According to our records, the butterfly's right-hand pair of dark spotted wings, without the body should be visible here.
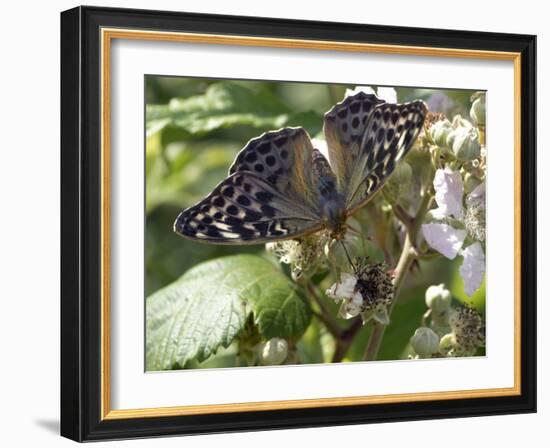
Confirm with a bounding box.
[325,92,427,215]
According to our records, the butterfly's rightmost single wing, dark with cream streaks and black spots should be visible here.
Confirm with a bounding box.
[346,101,428,215]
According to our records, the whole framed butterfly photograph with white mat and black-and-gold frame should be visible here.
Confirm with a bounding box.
[61,7,536,441]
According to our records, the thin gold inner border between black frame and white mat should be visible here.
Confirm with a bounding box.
[100,28,521,420]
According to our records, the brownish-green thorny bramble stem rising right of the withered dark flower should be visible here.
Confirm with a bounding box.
[364,191,433,361]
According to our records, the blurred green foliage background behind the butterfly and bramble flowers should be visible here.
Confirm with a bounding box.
[145,76,484,359]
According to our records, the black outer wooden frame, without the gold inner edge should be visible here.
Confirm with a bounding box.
[61,7,536,441]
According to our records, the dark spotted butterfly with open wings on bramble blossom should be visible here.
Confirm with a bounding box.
[174,92,427,244]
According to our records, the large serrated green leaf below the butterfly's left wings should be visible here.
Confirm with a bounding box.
[146,255,311,370]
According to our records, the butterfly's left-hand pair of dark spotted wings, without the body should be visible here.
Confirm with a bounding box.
[174,128,322,244]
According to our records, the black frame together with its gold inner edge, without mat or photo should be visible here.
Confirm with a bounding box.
[61,7,537,441]
